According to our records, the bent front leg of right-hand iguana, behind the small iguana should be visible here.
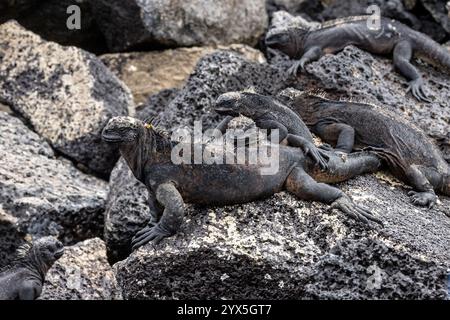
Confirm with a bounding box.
[314,122,355,153]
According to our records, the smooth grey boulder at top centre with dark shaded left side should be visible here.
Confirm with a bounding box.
[90,0,268,51]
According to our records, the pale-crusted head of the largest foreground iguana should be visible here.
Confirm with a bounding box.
[102,117,144,144]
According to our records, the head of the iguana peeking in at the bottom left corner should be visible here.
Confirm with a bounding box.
[17,237,64,270]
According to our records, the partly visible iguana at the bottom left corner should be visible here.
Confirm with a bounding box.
[0,237,64,300]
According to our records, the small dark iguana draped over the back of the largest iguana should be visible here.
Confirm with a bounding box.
[214,90,328,170]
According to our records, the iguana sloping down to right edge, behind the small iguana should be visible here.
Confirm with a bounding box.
[279,89,450,208]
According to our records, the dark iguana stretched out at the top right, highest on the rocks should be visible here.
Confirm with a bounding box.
[266,16,450,102]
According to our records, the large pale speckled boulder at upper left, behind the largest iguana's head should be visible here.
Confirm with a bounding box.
[0,22,134,176]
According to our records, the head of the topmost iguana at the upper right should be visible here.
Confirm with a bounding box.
[266,27,308,58]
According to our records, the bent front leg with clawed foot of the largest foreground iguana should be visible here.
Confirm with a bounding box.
[131,182,184,250]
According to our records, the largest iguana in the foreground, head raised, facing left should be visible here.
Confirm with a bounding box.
[102,117,380,249]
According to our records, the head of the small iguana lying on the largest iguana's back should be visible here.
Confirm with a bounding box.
[214,91,271,119]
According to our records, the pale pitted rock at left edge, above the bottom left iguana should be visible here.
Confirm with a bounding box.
[0,112,108,243]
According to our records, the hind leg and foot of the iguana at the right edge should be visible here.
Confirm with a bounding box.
[405,166,437,209]
